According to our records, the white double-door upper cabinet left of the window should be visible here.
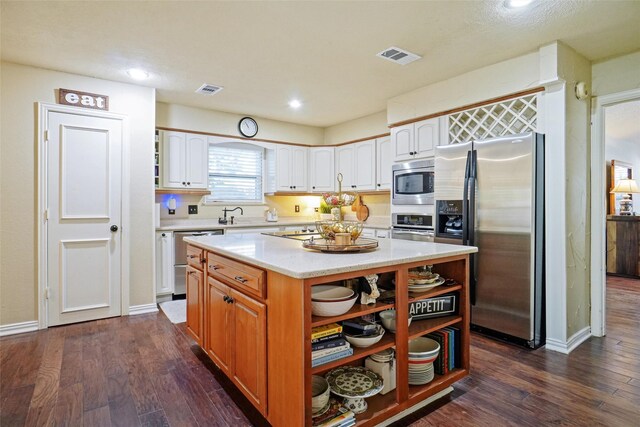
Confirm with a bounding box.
[162,131,208,189]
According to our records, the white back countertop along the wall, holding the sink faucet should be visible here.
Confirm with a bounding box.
[156,217,390,231]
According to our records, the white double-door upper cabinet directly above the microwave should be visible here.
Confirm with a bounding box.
[391,117,440,162]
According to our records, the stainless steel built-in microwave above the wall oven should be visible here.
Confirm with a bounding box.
[391,159,434,205]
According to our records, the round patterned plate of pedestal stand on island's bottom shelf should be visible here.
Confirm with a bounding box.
[325,366,383,397]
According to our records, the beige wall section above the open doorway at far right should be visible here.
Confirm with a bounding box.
[592,50,640,96]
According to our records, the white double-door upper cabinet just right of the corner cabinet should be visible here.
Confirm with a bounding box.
[335,139,376,191]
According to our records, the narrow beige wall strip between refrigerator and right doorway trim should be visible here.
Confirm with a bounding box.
[558,44,591,338]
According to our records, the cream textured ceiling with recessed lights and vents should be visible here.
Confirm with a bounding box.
[0,0,640,127]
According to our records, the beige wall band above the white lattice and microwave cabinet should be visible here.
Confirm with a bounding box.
[387,52,540,124]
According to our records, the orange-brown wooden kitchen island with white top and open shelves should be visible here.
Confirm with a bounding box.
[185,233,477,427]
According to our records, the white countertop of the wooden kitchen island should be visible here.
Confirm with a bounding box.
[184,233,478,279]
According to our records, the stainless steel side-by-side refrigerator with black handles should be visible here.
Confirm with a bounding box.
[434,133,545,348]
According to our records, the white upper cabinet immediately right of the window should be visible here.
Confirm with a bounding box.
[275,144,308,192]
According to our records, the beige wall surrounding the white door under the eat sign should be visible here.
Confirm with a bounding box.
[0,63,155,325]
